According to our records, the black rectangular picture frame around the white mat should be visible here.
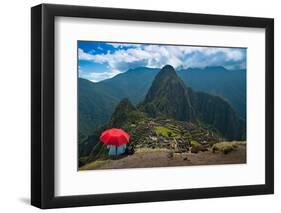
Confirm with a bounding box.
[31,4,274,209]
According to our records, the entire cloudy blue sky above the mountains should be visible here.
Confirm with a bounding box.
[78,41,247,82]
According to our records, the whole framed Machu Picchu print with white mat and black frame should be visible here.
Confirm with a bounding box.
[31,4,274,208]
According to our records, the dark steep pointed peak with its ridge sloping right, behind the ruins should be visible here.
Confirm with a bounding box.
[140,65,245,140]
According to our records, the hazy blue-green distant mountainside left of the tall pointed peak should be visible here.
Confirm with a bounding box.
[78,67,159,135]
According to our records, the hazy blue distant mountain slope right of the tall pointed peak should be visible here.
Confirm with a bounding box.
[177,67,246,119]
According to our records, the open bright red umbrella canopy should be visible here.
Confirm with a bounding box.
[100,128,130,146]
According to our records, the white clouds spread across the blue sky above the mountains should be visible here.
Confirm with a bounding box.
[78,43,246,79]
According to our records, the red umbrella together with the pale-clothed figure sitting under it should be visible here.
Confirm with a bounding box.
[100,128,130,157]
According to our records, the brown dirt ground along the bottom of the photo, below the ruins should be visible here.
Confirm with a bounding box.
[81,146,246,170]
